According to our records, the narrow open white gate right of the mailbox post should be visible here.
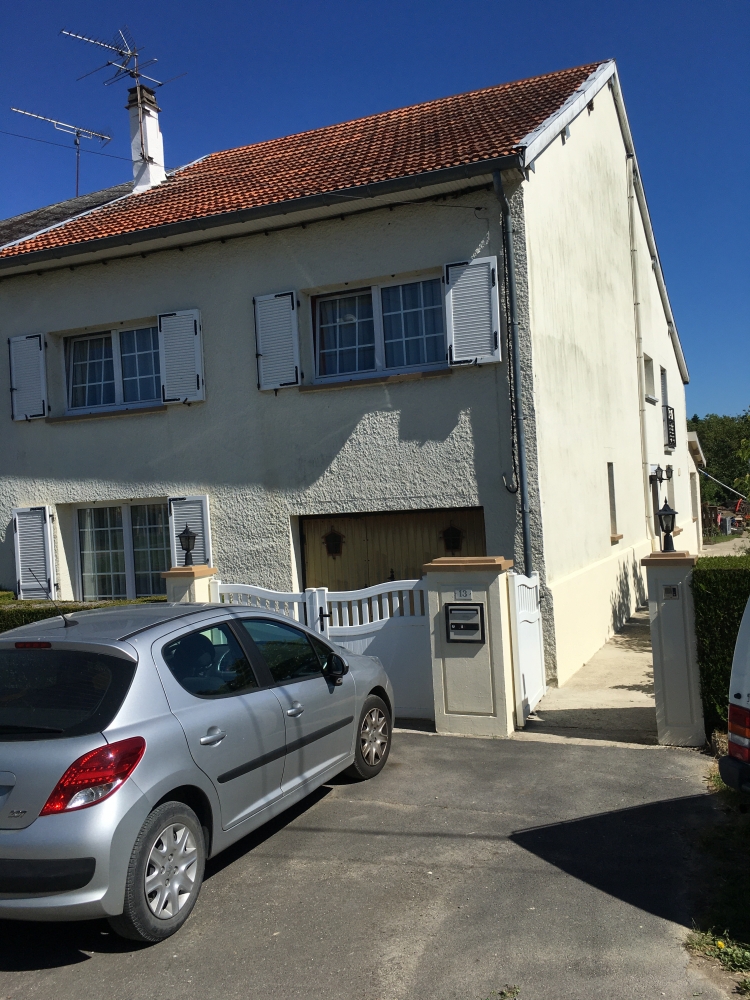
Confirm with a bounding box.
[508,571,546,726]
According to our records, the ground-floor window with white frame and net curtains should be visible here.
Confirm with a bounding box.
[78,502,171,601]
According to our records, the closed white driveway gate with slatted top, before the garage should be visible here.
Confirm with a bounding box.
[210,580,435,719]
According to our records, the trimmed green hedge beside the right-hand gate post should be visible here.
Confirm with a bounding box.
[693,556,750,736]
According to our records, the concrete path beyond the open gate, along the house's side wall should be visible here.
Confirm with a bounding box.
[518,611,657,744]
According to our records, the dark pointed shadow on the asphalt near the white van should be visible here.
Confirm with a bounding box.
[510,795,713,927]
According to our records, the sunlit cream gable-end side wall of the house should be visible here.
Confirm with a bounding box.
[524,90,695,683]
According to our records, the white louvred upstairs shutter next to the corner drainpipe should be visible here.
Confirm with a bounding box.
[445,257,501,365]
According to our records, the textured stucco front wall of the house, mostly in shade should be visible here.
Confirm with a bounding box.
[0,190,528,597]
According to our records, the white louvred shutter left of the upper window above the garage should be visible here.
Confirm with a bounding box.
[254,292,299,389]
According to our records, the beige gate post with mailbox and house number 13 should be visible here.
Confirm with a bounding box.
[424,556,515,736]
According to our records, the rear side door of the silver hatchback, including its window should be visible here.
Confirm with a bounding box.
[154,622,286,830]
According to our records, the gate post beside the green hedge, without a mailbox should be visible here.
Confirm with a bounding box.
[641,552,706,747]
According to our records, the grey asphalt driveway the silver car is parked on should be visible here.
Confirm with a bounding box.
[0,733,724,1000]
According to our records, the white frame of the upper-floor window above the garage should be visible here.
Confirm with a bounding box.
[310,267,450,385]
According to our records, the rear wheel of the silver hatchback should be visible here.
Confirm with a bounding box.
[109,802,206,943]
